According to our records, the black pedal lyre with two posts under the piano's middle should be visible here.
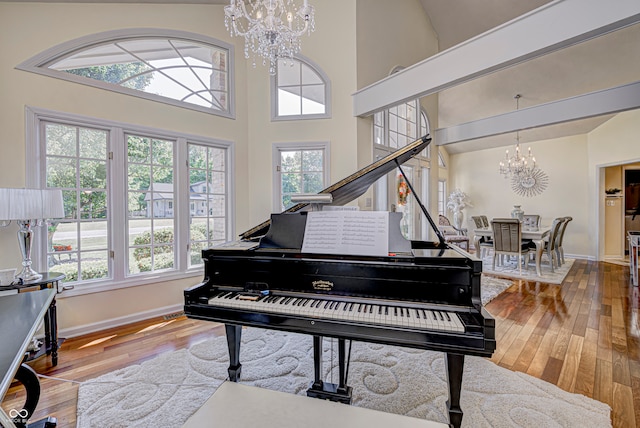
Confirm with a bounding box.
[307,336,352,404]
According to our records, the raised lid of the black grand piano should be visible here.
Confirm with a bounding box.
[240,135,431,239]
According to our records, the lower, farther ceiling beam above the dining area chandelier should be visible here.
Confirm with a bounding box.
[434,81,640,146]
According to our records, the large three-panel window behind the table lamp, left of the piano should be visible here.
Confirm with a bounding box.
[28,110,232,289]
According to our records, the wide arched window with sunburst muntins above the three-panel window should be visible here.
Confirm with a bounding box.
[16,29,234,117]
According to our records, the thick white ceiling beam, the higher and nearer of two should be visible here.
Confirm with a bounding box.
[353,0,640,116]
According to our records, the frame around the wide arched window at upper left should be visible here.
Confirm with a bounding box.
[15,28,236,119]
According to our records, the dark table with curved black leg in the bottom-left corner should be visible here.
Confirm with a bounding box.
[0,287,56,428]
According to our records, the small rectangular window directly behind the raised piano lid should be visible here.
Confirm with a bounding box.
[274,143,329,211]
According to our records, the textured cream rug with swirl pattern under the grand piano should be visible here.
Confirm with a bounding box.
[78,328,611,428]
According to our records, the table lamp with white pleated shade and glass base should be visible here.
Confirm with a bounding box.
[0,189,64,282]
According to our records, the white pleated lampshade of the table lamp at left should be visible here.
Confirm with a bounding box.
[0,189,64,220]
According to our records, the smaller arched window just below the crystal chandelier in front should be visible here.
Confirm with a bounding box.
[271,55,331,120]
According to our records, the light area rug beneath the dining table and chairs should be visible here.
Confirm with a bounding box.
[482,251,575,284]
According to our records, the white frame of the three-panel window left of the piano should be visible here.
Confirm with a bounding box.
[25,106,235,296]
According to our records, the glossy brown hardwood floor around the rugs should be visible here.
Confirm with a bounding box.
[2,260,640,428]
